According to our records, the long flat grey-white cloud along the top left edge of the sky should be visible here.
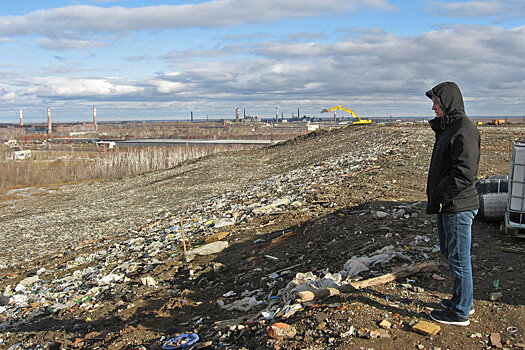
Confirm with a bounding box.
[0,0,395,38]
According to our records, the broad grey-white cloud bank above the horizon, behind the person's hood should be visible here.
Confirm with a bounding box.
[0,26,525,116]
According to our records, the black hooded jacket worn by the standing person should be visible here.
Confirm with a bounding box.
[426,82,480,214]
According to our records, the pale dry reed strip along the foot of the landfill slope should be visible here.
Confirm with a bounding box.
[0,145,250,190]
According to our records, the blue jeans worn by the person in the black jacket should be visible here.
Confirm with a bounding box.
[436,210,478,319]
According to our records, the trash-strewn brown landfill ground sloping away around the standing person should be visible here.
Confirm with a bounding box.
[0,125,525,350]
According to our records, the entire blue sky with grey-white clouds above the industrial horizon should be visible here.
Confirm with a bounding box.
[0,0,525,122]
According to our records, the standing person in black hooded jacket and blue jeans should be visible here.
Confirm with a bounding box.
[426,82,480,326]
